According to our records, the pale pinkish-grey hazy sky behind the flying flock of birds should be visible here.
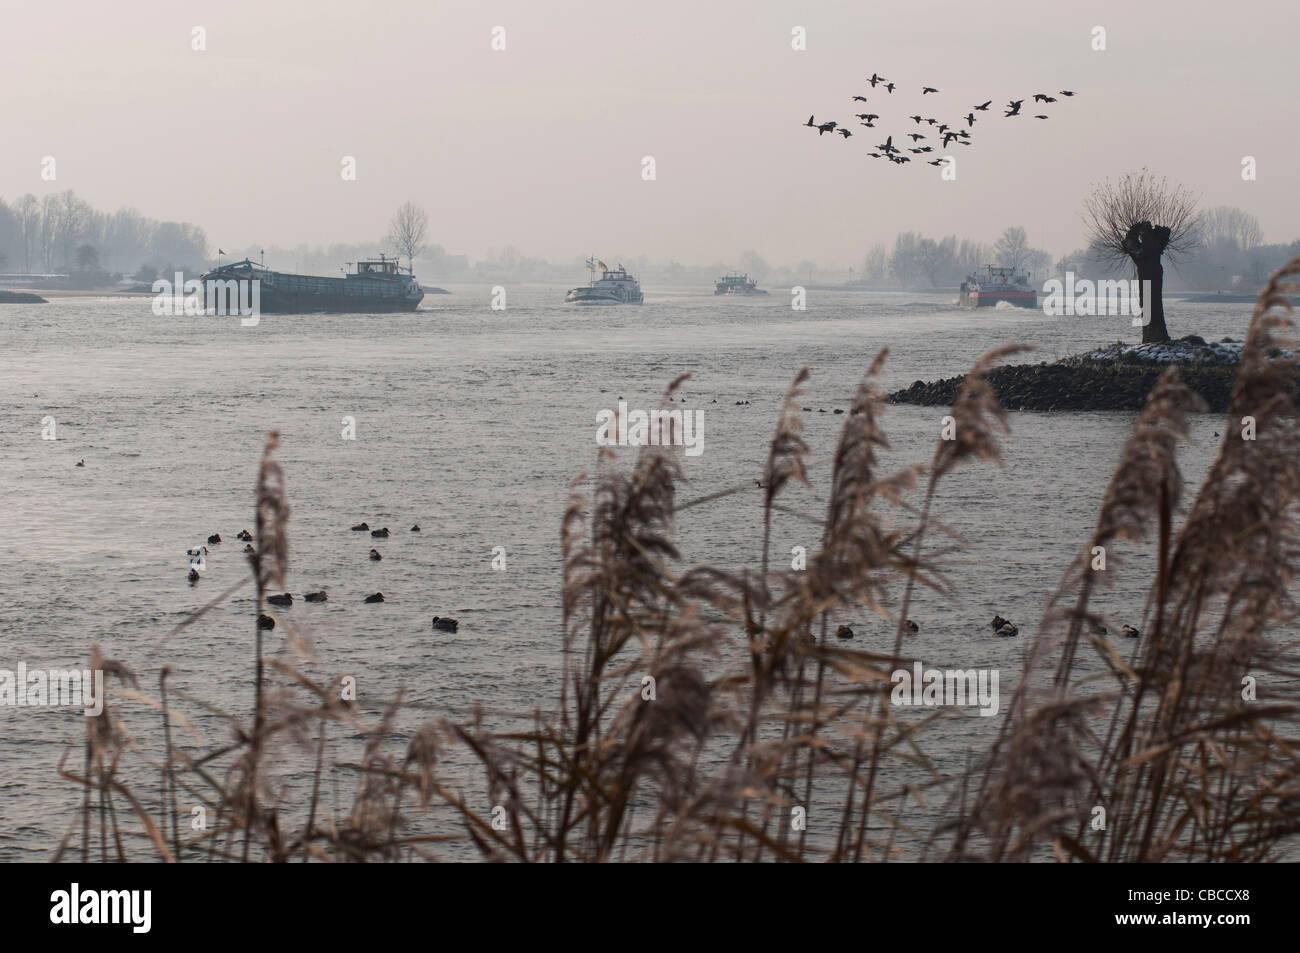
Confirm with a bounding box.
[0,0,1300,267]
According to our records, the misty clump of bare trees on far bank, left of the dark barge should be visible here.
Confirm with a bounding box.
[0,190,208,285]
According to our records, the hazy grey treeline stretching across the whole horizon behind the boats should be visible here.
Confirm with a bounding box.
[0,190,1300,291]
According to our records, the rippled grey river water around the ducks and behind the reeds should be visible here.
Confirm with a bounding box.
[0,286,1251,859]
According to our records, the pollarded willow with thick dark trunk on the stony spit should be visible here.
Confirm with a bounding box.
[1083,169,1200,345]
